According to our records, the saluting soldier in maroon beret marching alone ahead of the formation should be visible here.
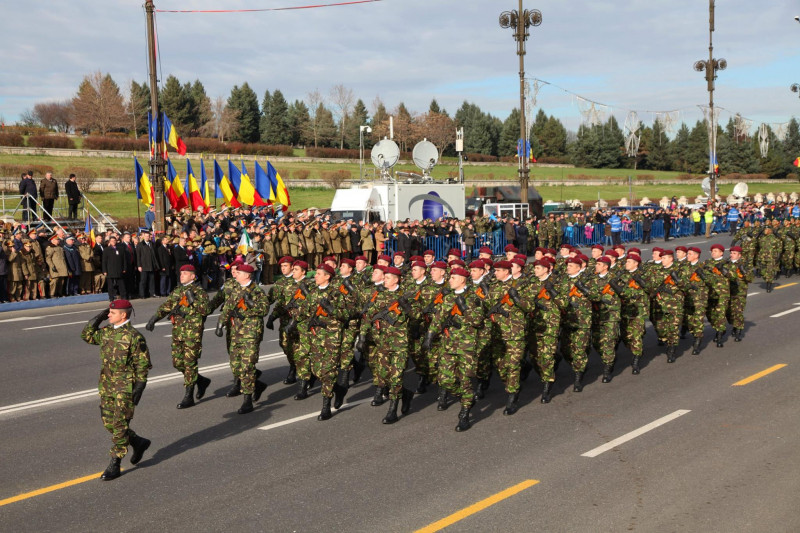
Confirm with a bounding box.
[81,300,152,481]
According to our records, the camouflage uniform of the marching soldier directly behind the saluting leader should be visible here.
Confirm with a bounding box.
[155,283,210,387]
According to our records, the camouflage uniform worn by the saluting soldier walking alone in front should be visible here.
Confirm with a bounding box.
[81,321,152,458]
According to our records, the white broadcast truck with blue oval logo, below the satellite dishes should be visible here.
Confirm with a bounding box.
[331,183,466,221]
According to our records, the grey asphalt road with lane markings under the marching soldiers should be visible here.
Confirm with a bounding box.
[0,236,800,532]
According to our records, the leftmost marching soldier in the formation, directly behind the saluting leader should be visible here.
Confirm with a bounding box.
[145,265,211,409]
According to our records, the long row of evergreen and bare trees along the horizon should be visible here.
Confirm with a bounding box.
[15,72,800,177]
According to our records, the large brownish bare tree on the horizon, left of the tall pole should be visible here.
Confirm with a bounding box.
[72,70,126,135]
